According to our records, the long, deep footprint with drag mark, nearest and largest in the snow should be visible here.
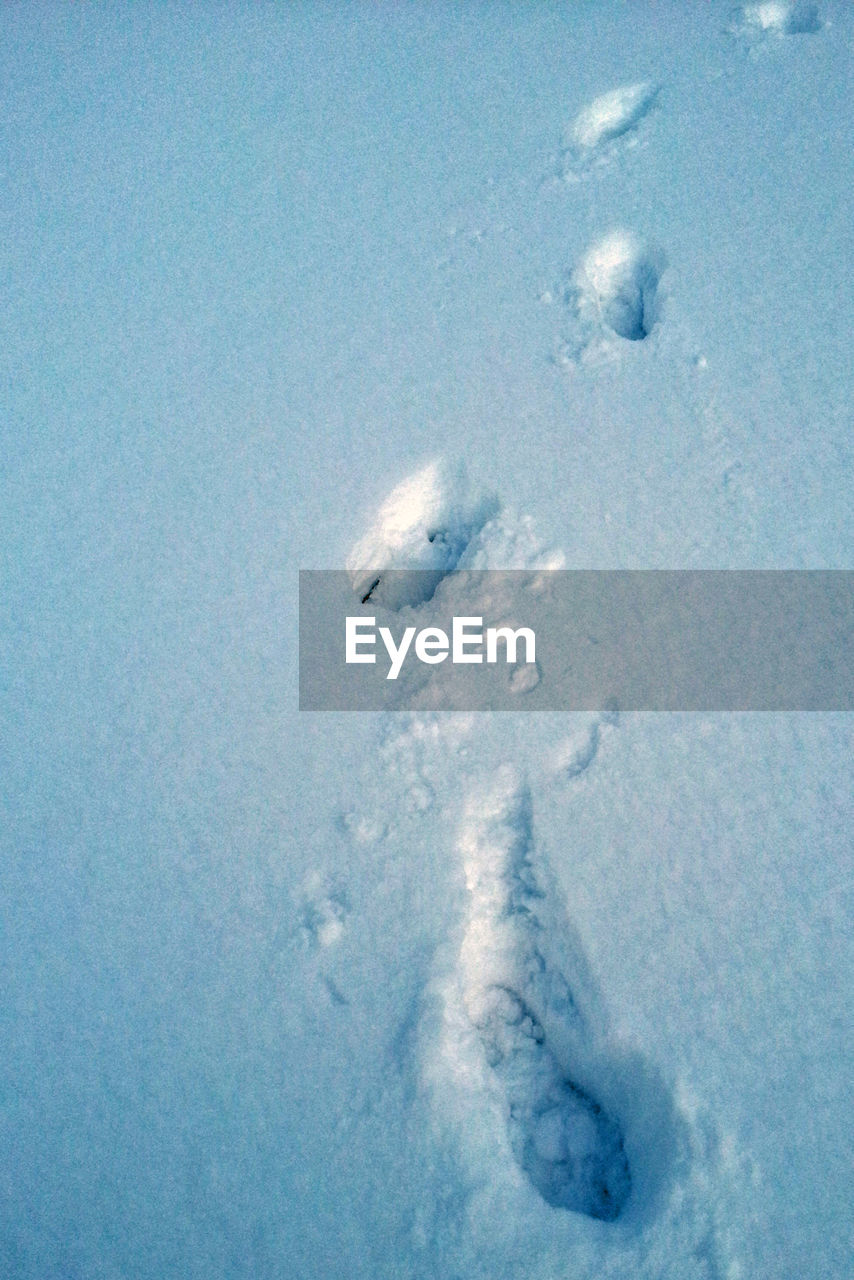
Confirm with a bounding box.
[460,772,631,1221]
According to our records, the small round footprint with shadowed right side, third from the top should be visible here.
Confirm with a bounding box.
[570,232,666,342]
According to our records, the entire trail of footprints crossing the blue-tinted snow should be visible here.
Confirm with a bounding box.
[332,0,822,1239]
